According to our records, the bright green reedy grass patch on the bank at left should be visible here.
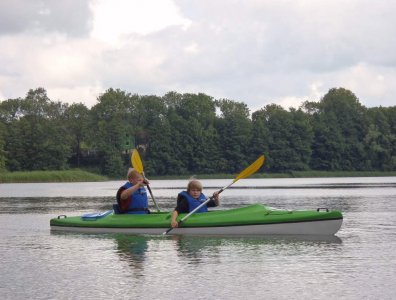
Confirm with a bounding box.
[0,169,108,183]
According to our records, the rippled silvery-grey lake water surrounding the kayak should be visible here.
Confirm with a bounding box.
[0,177,396,300]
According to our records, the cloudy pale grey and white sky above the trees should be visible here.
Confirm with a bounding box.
[0,0,396,111]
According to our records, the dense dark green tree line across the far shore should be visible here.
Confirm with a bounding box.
[0,88,396,177]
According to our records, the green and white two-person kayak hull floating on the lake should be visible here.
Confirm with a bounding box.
[50,204,343,235]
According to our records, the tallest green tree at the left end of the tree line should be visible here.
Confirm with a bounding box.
[6,88,70,171]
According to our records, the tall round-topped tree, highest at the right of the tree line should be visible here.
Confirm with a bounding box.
[311,88,367,170]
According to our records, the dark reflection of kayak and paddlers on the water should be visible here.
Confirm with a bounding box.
[51,231,342,277]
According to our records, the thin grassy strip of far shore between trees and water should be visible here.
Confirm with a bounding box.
[0,169,396,183]
